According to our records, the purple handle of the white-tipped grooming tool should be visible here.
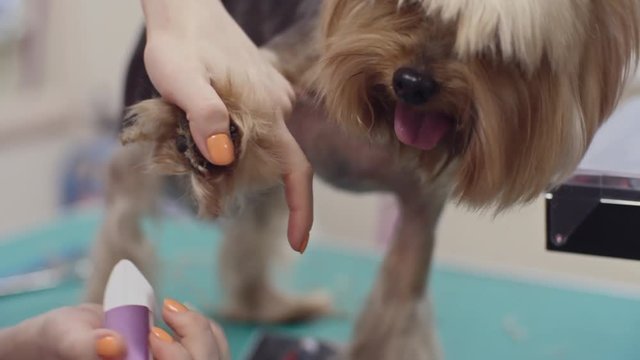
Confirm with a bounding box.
[105,305,151,360]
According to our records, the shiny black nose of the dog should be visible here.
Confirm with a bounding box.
[393,68,438,105]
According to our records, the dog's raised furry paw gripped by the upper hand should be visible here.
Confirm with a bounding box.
[121,82,282,217]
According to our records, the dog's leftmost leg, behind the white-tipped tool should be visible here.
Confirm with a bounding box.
[85,144,159,303]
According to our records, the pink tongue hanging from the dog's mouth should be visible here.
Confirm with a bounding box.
[394,102,451,150]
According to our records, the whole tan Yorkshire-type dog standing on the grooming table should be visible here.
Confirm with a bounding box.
[88,0,640,360]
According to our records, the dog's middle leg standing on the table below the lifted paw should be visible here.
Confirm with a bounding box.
[220,188,331,323]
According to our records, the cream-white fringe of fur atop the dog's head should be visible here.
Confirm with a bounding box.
[399,0,602,71]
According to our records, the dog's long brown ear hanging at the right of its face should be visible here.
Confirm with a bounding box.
[456,0,640,208]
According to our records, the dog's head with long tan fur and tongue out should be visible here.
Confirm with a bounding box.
[312,0,640,206]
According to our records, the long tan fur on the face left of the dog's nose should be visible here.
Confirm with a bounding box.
[307,0,423,138]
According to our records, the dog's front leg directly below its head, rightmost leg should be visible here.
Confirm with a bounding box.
[348,194,445,360]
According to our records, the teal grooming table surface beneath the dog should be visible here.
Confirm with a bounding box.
[0,212,640,360]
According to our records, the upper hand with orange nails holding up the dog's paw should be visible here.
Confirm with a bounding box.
[141,0,313,252]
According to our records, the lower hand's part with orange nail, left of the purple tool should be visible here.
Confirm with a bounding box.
[0,304,126,360]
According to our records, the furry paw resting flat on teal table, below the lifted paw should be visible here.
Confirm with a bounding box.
[221,290,333,324]
